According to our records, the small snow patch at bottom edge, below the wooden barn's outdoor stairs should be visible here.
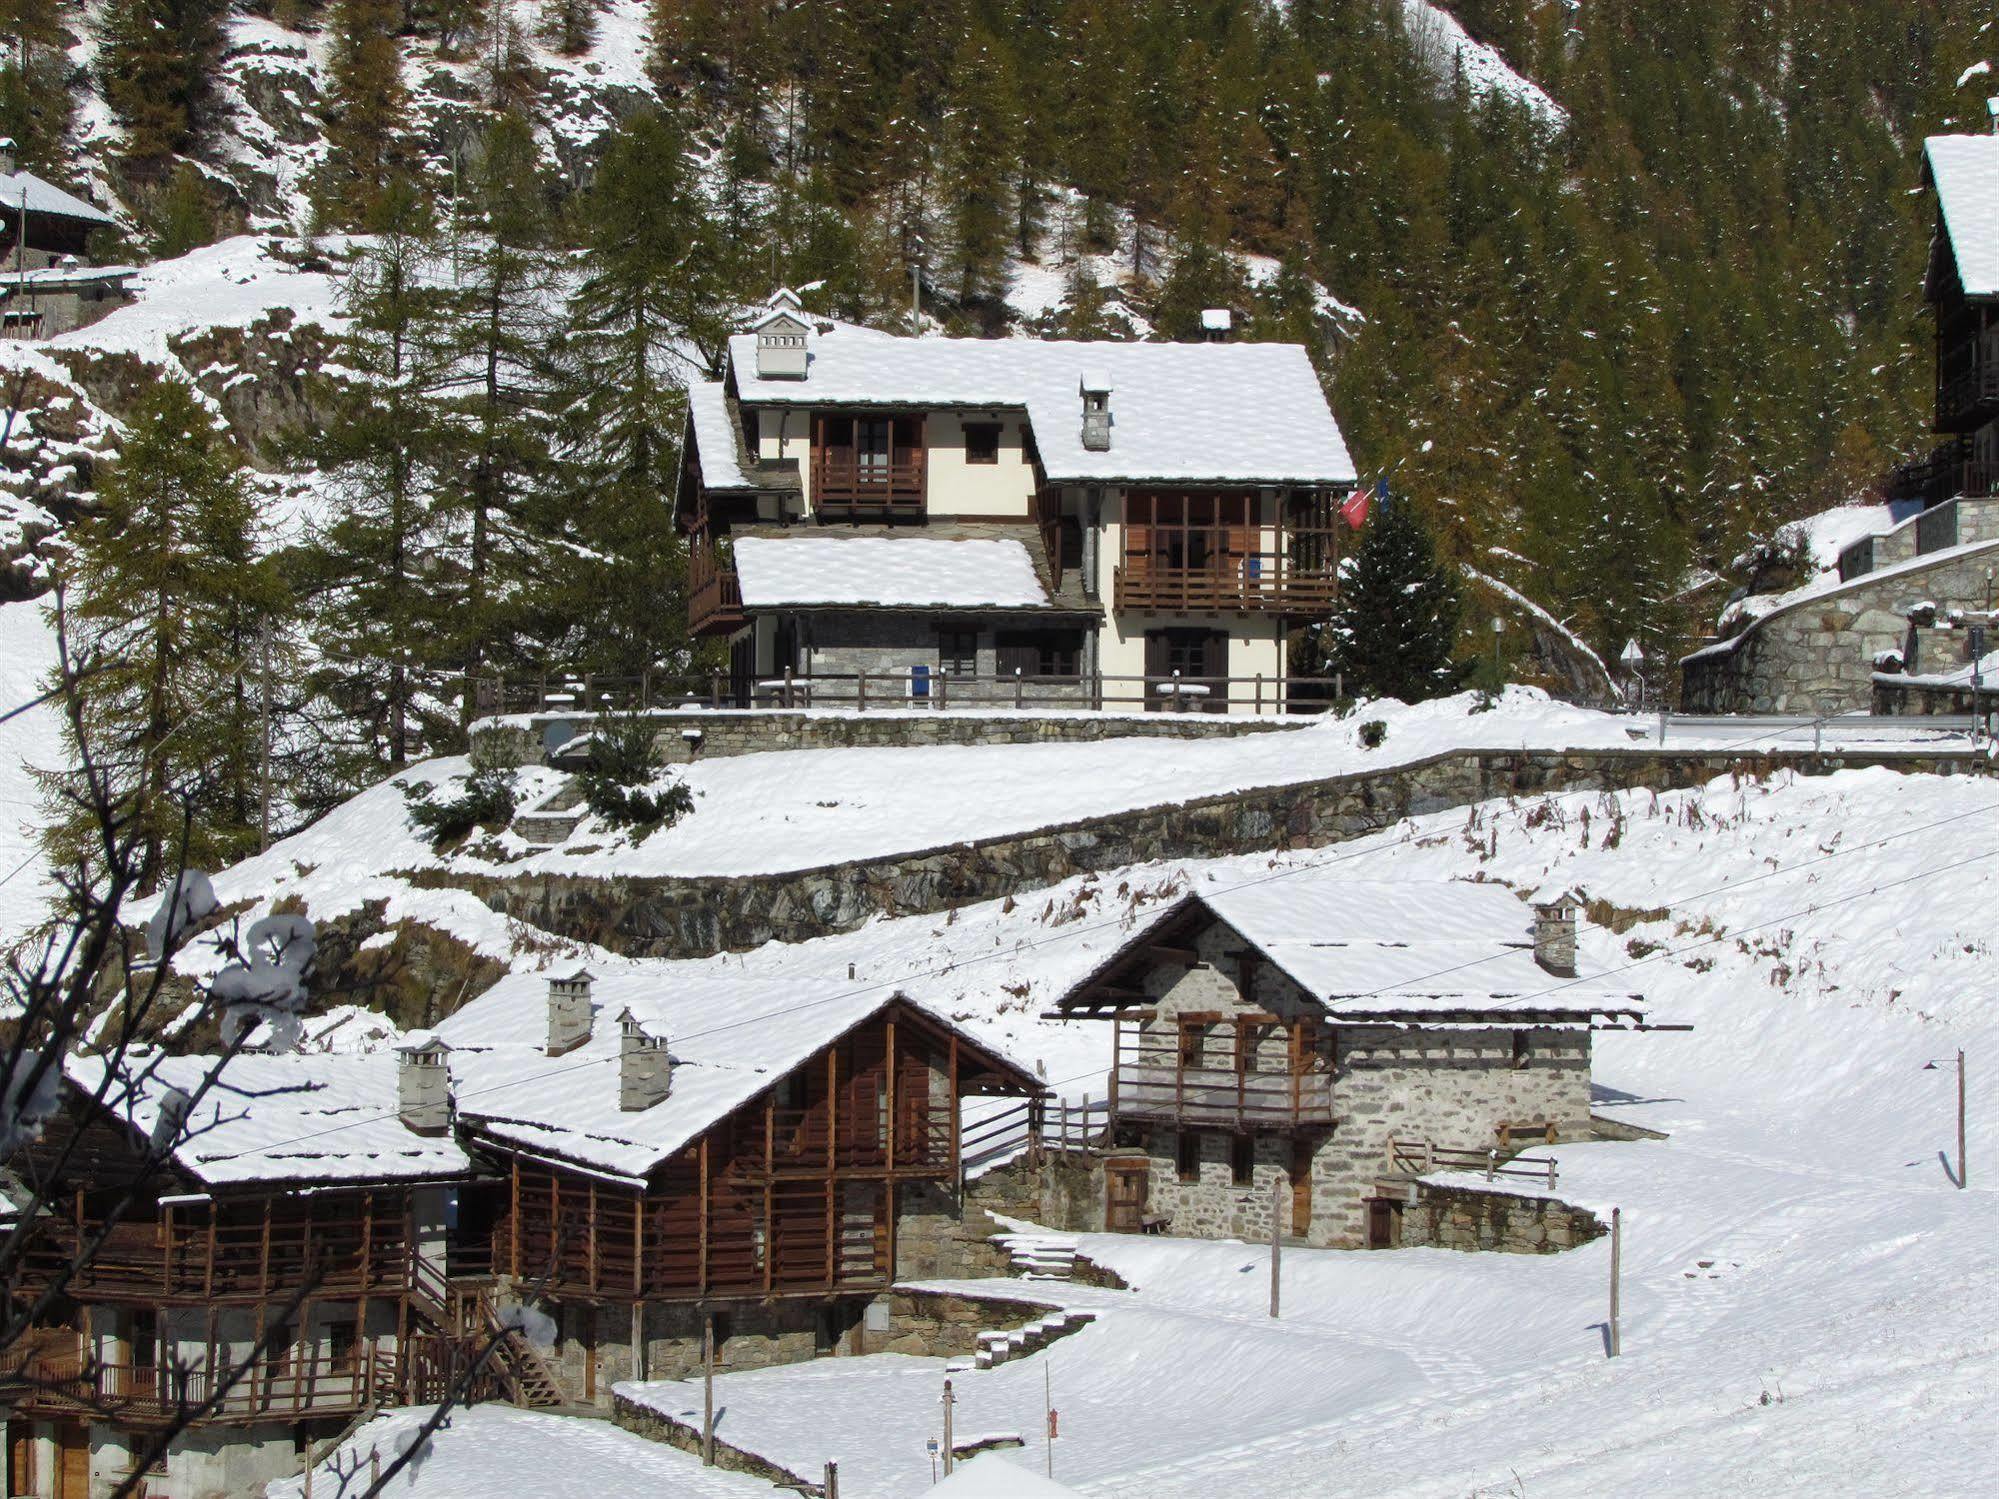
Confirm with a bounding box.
[266,1405,776,1499]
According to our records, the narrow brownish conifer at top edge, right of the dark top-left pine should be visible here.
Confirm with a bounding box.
[316,0,408,226]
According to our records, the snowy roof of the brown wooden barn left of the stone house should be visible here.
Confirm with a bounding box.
[438,959,1025,1181]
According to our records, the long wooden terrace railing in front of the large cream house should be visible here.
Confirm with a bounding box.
[462,668,1341,724]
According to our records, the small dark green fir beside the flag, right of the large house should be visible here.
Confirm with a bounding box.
[1319,500,1463,704]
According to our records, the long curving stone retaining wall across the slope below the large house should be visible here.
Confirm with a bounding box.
[463,746,1989,957]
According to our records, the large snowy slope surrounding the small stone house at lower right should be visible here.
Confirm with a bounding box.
[622,769,1999,1499]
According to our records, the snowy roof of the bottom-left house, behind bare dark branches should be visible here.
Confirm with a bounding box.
[66,1051,472,1187]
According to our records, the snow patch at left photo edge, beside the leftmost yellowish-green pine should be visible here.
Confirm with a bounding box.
[0,602,62,947]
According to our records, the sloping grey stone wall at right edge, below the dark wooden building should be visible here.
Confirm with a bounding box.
[1681,539,1999,714]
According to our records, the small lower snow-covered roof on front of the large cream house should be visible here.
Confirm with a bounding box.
[736,536,1047,610]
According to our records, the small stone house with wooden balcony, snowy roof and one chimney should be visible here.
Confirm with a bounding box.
[1057,869,1643,1247]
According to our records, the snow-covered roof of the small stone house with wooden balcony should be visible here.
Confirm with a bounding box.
[1079,879,1641,1015]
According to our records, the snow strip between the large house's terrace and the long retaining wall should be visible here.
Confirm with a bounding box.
[190,688,1963,955]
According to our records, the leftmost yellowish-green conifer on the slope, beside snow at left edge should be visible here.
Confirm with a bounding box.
[48,380,286,889]
